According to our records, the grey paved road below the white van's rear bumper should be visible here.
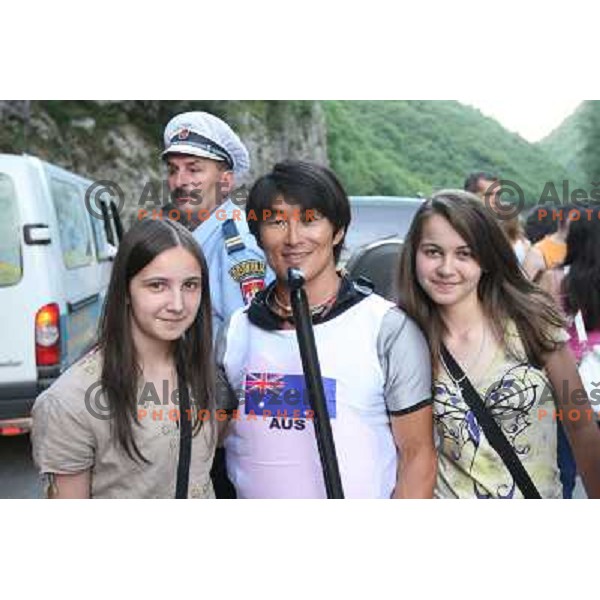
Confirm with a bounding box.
[0,435,42,498]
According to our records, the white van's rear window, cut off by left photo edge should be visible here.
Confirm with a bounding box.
[0,173,22,287]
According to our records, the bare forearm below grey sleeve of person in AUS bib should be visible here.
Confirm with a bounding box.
[391,406,437,499]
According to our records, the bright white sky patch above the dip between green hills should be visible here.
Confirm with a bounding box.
[459,98,582,142]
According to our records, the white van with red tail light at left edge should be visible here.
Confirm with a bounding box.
[0,154,122,435]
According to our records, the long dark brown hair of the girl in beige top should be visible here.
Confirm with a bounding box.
[98,219,215,462]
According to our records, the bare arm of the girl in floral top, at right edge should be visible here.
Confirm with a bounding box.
[545,344,600,498]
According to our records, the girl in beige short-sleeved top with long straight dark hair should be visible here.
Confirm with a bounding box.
[32,220,216,498]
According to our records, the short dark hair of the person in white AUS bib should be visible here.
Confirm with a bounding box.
[246,160,351,263]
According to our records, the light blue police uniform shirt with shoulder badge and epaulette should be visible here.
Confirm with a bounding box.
[193,199,274,336]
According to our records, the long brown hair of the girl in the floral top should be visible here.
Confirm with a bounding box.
[399,190,565,367]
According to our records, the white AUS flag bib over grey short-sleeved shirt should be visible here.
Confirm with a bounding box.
[217,279,431,498]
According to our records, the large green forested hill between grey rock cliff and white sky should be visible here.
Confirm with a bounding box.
[323,100,571,202]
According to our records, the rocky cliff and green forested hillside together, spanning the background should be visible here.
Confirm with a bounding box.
[0,100,582,209]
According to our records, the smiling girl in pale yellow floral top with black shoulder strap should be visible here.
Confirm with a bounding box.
[399,190,600,498]
